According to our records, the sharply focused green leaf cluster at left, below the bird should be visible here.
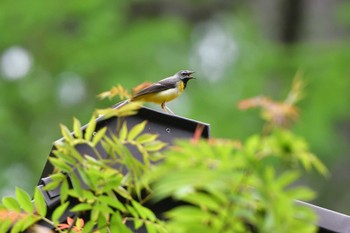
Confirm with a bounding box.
[0,110,166,232]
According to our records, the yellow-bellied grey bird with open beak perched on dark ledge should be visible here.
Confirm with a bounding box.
[121,70,195,114]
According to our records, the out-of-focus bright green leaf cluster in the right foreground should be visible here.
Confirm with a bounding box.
[149,131,326,233]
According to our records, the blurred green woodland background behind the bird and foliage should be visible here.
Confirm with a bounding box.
[0,0,350,214]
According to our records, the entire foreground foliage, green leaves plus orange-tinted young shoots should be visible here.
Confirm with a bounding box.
[0,73,328,233]
